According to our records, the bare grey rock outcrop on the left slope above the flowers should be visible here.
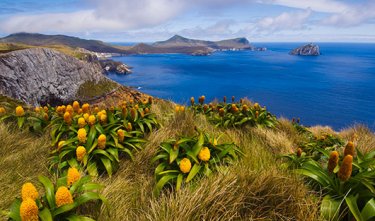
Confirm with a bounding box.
[0,48,114,105]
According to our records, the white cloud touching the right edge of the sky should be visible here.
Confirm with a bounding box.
[321,1,375,27]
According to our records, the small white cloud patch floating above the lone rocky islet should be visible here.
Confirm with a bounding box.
[255,9,312,33]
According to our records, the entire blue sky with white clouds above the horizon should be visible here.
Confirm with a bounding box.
[0,0,375,42]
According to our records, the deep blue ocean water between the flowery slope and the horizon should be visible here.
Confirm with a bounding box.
[109,43,375,130]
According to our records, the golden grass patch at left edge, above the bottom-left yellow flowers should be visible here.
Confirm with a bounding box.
[0,123,50,219]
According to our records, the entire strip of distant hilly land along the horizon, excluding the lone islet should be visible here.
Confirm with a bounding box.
[0,33,267,58]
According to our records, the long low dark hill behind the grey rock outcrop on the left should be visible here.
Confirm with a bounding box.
[0,33,126,53]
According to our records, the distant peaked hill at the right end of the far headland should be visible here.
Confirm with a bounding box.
[153,35,253,50]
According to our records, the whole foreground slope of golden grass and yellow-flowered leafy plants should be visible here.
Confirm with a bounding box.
[0,97,375,220]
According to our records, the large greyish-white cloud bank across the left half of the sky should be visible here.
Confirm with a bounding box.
[0,0,185,33]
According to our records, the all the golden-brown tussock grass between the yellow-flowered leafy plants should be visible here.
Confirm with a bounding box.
[0,101,375,220]
